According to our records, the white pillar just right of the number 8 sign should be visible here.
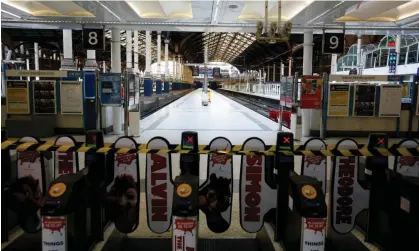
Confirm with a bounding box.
[111,28,123,134]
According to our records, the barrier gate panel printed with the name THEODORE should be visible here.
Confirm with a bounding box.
[331,139,369,234]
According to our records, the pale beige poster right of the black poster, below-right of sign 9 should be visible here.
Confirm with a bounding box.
[378,84,402,117]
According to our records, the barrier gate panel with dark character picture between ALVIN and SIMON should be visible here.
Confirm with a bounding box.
[199,137,233,233]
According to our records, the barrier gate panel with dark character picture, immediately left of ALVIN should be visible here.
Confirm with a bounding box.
[107,136,140,233]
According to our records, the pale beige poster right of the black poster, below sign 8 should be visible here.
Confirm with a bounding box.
[60,81,83,114]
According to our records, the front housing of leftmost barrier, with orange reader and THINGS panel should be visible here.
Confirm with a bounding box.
[41,169,93,251]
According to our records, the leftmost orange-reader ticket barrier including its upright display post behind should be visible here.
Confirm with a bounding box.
[4,131,112,251]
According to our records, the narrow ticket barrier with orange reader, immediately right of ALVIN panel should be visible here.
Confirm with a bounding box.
[172,132,199,251]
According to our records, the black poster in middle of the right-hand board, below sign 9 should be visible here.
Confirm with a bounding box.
[353,84,375,117]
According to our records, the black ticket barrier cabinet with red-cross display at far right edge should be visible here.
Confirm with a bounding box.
[356,134,419,250]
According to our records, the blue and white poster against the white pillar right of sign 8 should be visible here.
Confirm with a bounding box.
[100,73,122,106]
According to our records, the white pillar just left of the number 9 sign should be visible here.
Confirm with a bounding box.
[301,30,313,137]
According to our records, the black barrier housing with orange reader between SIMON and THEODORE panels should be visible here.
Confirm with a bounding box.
[281,175,327,251]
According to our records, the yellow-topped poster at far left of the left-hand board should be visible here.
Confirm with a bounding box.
[6,80,30,114]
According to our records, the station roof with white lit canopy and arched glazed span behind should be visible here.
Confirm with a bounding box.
[1,0,419,68]
